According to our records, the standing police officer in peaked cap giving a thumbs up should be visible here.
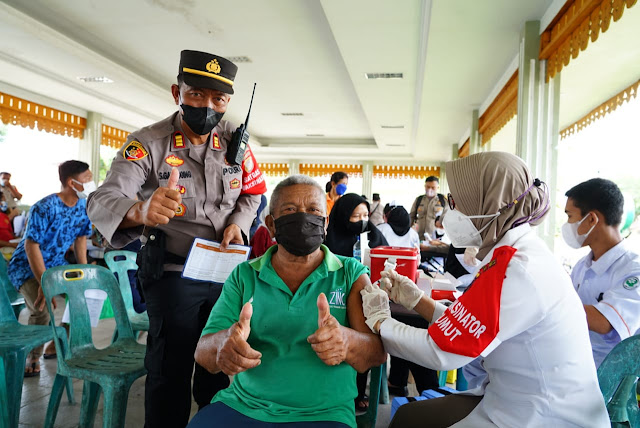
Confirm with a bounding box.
[87,50,266,427]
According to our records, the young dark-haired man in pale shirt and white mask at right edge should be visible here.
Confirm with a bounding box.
[562,178,640,367]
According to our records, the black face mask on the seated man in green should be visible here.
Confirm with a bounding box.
[275,213,325,256]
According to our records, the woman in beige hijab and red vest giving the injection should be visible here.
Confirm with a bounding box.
[362,152,609,428]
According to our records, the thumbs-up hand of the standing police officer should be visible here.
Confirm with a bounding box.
[136,168,184,227]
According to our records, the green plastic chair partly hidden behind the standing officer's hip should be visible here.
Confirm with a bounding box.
[104,250,149,341]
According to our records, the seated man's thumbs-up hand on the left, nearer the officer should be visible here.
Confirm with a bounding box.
[216,302,262,376]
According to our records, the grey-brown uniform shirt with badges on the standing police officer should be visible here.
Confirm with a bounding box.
[88,112,260,257]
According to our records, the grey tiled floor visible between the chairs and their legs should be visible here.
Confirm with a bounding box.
[19,300,404,428]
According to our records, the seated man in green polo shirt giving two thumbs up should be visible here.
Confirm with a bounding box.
[189,175,387,428]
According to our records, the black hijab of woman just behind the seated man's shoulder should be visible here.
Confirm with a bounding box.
[324,193,389,257]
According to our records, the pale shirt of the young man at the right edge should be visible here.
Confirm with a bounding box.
[571,241,640,367]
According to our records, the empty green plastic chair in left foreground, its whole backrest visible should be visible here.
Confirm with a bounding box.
[42,265,146,428]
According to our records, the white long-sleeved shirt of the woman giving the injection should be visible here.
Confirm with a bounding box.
[380,224,610,428]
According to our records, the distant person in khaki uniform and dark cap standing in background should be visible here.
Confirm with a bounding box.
[409,175,447,241]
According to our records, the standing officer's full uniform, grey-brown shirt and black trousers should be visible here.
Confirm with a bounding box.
[87,113,264,428]
